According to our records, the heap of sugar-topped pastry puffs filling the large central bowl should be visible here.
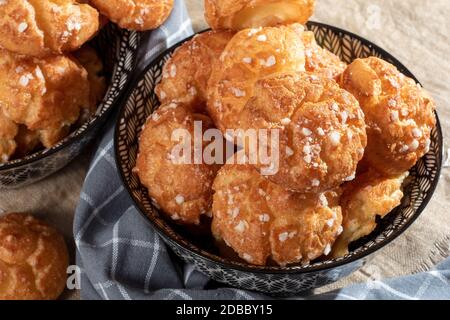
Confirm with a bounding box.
[134,0,436,266]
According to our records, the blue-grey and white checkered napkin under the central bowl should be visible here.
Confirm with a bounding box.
[74,0,450,300]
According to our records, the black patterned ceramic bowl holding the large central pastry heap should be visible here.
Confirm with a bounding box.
[115,22,442,295]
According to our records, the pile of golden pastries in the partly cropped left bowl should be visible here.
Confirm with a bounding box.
[0,0,173,164]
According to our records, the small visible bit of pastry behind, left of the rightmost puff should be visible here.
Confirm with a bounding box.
[302,31,347,79]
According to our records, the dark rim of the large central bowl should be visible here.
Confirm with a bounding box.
[114,21,443,275]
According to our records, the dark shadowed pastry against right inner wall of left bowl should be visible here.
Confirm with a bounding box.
[73,45,106,113]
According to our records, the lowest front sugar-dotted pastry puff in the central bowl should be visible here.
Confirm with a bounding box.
[212,164,342,266]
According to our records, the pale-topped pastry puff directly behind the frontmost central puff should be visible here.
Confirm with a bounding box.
[207,24,305,132]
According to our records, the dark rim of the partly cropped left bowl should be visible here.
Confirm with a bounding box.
[0,25,137,173]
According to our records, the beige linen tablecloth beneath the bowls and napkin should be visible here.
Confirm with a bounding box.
[0,0,450,298]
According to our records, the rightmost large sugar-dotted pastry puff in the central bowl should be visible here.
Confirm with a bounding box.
[342,57,436,176]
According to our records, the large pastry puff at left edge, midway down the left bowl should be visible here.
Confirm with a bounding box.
[0,50,90,148]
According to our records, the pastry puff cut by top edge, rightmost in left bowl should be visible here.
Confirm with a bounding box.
[90,0,174,31]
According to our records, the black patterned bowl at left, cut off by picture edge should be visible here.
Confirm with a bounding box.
[0,24,140,189]
